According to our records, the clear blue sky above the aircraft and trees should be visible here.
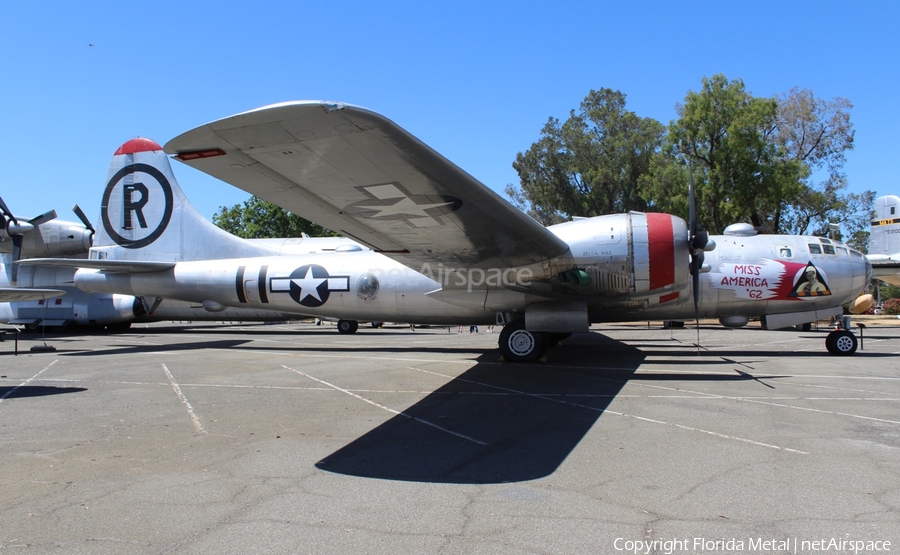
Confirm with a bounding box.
[0,0,900,228]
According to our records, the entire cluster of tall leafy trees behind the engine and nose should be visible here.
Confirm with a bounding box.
[506,74,874,243]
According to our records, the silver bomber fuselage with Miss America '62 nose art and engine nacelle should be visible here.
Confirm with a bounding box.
[75,213,871,324]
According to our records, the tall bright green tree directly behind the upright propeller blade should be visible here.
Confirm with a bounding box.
[645,74,807,233]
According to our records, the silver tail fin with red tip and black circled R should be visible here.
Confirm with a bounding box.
[90,138,272,262]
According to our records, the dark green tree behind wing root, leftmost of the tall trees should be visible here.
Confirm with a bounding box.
[506,89,665,225]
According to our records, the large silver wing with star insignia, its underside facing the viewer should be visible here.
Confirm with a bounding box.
[164,101,568,269]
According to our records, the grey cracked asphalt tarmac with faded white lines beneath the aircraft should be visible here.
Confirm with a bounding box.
[0,323,900,554]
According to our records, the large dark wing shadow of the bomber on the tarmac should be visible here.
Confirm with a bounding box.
[316,333,768,484]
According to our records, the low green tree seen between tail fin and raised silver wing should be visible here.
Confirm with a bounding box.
[212,196,337,239]
